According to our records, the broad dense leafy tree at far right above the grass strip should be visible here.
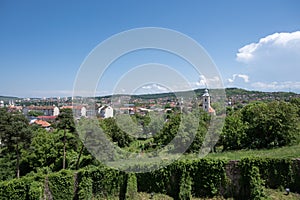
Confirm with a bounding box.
[241,101,298,148]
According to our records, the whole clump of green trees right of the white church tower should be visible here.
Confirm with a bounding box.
[221,101,299,150]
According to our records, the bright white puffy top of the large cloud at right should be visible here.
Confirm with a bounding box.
[236,31,300,63]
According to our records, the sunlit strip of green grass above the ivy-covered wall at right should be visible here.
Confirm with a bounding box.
[184,144,300,160]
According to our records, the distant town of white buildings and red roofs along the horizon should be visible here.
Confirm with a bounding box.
[0,88,300,129]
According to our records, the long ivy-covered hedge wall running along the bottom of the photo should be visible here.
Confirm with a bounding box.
[0,158,300,200]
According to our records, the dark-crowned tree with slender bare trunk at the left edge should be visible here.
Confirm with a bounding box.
[0,109,32,178]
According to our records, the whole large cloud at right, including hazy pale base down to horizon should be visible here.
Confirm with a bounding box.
[236,31,300,92]
